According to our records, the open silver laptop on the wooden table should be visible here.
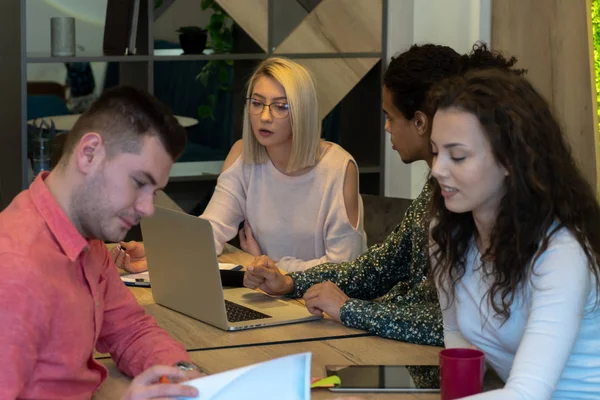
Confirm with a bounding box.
[141,206,321,331]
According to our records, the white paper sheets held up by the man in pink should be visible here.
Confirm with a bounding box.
[179,353,311,400]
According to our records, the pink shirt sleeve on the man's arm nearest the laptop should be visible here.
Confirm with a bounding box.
[96,244,189,376]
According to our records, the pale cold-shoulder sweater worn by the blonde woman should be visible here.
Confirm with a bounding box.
[200,143,366,271]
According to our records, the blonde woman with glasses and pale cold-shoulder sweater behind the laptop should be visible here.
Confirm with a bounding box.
[113,58,366,272]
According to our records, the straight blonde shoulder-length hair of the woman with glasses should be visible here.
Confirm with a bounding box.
[242,57,321,173]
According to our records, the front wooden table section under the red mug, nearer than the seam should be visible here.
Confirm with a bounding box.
[93,336,440,400]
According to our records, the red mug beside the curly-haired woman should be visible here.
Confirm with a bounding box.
[440,348,485,400]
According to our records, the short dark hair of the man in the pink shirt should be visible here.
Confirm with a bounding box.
[62,86,186,162]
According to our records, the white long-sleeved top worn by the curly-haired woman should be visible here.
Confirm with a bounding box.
[439,229,600,400]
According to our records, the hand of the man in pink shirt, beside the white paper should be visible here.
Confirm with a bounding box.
[122,365,198,400]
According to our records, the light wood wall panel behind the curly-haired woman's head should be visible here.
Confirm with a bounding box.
[491,0,598,194]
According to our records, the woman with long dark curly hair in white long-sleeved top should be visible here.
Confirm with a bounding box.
[430,69,600,400]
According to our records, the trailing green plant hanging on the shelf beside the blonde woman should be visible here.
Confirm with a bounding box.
[196,0,233,120]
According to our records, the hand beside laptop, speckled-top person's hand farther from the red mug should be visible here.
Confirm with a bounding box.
[244,256,294,295]
